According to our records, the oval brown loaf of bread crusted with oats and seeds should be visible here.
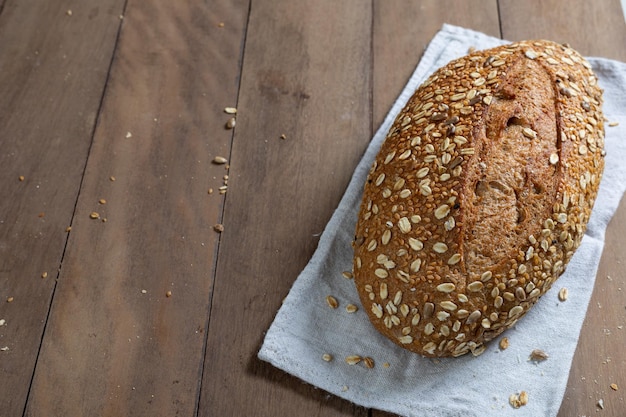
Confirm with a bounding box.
[353,41,605,357]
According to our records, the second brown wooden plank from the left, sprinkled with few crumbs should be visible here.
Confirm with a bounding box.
[26,0,248,416]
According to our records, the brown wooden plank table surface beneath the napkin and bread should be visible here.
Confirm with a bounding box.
[0,0,626,417]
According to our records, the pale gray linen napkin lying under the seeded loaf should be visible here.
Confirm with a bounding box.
[259,25,626,417]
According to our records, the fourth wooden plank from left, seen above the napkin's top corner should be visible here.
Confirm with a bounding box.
[373,0,500,129]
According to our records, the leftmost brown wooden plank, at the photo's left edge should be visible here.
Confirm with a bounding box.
[0,0,123,416]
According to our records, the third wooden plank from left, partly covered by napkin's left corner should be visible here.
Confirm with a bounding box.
[199,0,372,416]
